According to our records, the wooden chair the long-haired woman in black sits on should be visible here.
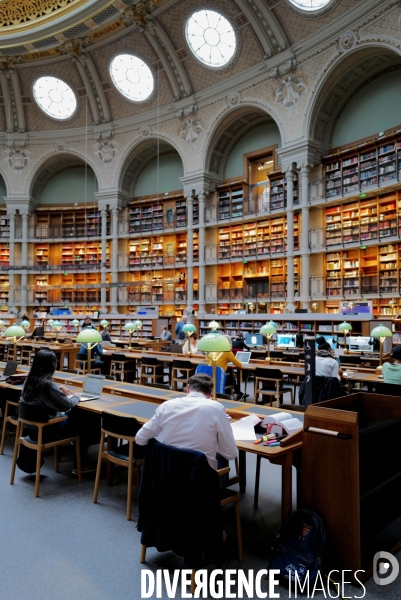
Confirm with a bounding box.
[10,402,82,498]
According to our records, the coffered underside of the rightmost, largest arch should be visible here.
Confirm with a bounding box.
[306,43,401,151]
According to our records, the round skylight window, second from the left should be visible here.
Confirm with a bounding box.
[110,54,154,102]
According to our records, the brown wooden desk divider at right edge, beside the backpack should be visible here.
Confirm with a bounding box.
[300,392,401,583]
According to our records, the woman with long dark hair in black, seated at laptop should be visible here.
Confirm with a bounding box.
[17,350,100,474]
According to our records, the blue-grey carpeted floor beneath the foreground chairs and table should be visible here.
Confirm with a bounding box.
[0,426,401,600]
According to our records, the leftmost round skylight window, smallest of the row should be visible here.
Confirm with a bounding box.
[33,77,77,119]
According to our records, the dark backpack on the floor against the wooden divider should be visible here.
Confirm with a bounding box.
[268,509,326,587]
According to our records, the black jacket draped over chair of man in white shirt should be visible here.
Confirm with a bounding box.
[138,440,222,568]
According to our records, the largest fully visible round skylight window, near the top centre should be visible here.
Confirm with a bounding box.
[185,10,237,67]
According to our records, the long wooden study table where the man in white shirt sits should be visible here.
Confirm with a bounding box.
[0,363,303,520]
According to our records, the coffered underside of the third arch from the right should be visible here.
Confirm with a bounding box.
[117,136,185,196]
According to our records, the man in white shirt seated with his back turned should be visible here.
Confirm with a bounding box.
[135,374,237,469]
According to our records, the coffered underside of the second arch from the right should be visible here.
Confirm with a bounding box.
[203,103,284,180]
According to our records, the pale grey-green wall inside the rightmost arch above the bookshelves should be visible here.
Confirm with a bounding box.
[332,71,401,148]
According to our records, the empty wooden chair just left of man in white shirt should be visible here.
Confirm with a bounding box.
[93,411,143,521]
